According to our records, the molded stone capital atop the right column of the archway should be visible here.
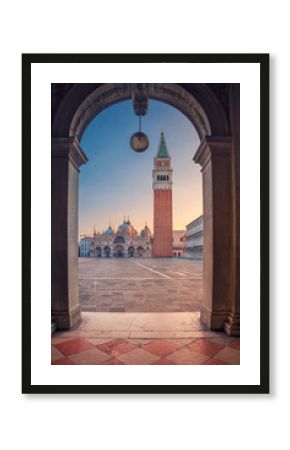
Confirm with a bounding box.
[193,136,232,169]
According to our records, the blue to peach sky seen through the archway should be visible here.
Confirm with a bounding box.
[79,100,202,235]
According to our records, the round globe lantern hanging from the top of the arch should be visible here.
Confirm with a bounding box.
[130,84,149,153]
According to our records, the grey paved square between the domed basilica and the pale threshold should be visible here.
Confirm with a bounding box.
[79,258,202,312]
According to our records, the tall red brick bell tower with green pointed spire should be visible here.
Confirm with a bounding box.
[152,130,173,257]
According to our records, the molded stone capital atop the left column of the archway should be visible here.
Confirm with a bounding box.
[51,137,88,170]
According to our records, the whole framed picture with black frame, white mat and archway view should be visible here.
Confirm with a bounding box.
[22,54,269,394]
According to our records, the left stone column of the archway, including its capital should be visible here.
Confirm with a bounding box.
[51,137,88,329]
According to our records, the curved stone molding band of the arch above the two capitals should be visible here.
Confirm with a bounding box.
[69,83,211,140]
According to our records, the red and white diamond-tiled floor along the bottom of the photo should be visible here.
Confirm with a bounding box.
[51,333,240,365]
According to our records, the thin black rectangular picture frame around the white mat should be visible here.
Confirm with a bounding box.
[22,53,270,394]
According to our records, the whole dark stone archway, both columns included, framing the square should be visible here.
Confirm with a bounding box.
[52,83,240,336]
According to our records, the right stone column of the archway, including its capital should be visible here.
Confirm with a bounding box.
[194,136,233,330]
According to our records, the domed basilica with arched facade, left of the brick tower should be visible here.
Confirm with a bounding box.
[79,218,151,258]
